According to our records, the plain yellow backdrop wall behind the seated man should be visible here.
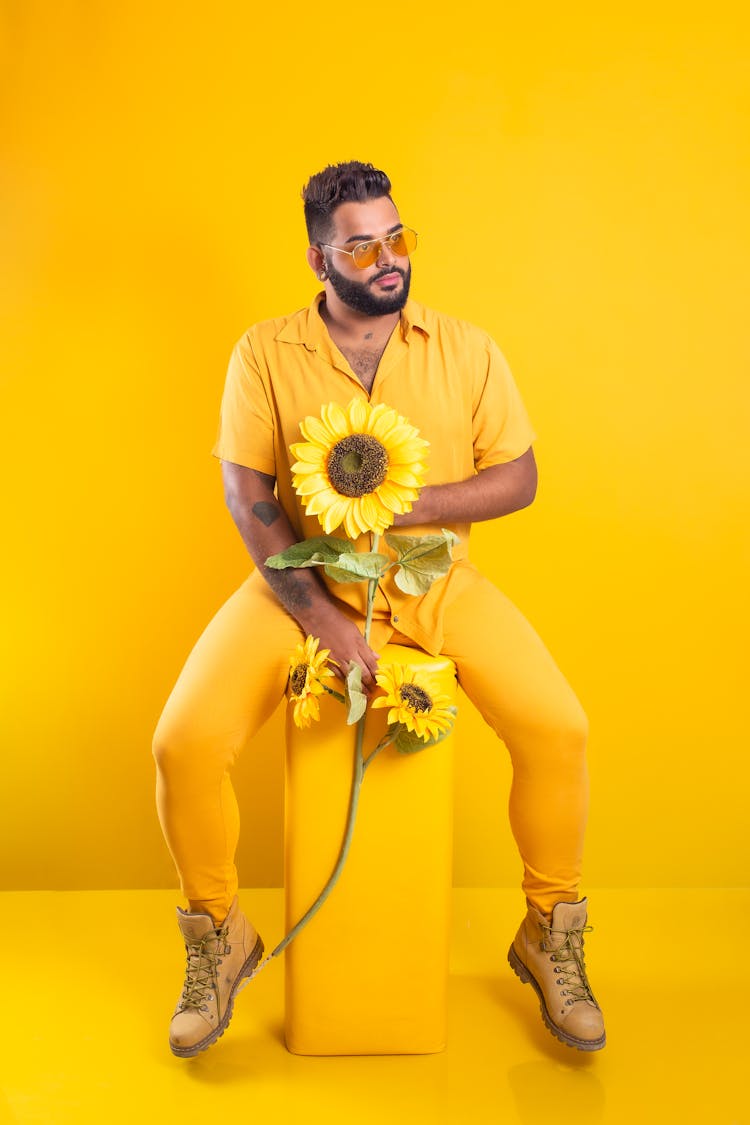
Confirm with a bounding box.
[0,0,750,888]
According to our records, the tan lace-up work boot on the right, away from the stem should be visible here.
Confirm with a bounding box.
[508,899,606,1051]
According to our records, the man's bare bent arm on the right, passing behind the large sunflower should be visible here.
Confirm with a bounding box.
[394,448,536,528]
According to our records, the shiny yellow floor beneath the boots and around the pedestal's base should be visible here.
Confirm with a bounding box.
[0,890,750,1125]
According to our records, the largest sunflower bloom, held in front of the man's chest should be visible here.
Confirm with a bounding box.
[291,398,430,539]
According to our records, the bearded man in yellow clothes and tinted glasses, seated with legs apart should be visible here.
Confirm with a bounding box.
[154,162,605,1056]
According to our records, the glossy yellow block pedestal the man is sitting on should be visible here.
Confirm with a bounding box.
[284,645,455,1055]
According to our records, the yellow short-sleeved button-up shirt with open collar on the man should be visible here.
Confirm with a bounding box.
[214,294,534,654]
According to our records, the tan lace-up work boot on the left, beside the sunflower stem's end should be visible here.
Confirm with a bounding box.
[170,896,263,1059]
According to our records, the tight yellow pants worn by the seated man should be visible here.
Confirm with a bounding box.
[154,574,588,923]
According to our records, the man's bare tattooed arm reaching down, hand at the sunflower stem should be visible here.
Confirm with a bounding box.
[222,461,378,689]
